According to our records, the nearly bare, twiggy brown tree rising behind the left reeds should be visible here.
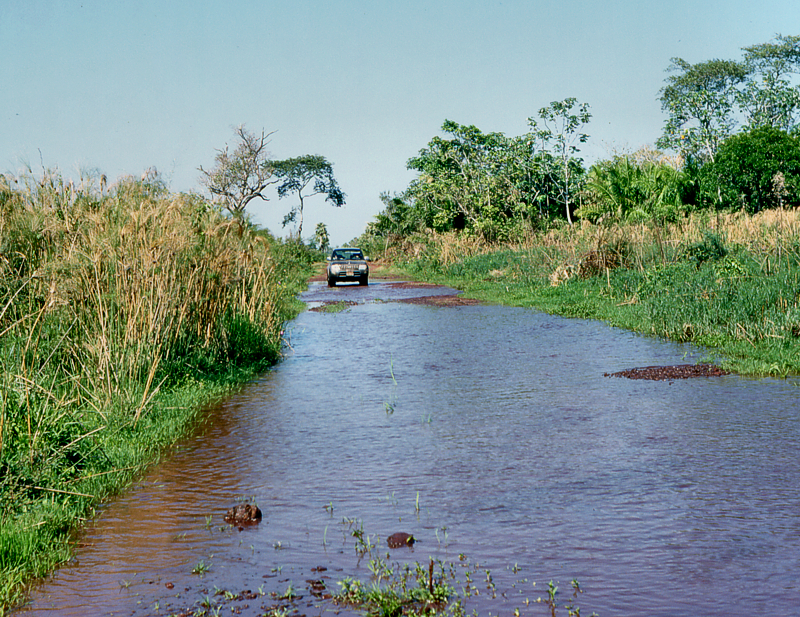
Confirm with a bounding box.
[199,125,277,218]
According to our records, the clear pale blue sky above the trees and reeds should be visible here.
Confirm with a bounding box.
[0,0,800,243]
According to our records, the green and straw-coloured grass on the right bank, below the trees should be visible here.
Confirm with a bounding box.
[394,214,800,376]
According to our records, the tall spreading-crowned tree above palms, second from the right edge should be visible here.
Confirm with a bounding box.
[657,58,748,164]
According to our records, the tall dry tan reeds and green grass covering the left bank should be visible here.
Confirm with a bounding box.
[0,166,311,615]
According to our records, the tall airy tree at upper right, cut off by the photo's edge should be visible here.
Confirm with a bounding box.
[739,35,800,131]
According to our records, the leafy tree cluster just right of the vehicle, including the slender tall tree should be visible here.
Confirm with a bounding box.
[370,111,588,240]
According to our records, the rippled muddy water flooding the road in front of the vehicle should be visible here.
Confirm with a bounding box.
[17,282,800,616]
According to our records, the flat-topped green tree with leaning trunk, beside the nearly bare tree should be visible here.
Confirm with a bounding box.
[274,154,345,238]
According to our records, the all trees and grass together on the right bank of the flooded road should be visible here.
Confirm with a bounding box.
[354,35,800,376]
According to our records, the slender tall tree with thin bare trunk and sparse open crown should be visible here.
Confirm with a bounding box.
[528,97,592,225]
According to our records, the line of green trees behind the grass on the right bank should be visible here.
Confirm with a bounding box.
[360,35,800,246]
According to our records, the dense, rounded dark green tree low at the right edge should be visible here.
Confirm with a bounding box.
[700,127,800,213]
